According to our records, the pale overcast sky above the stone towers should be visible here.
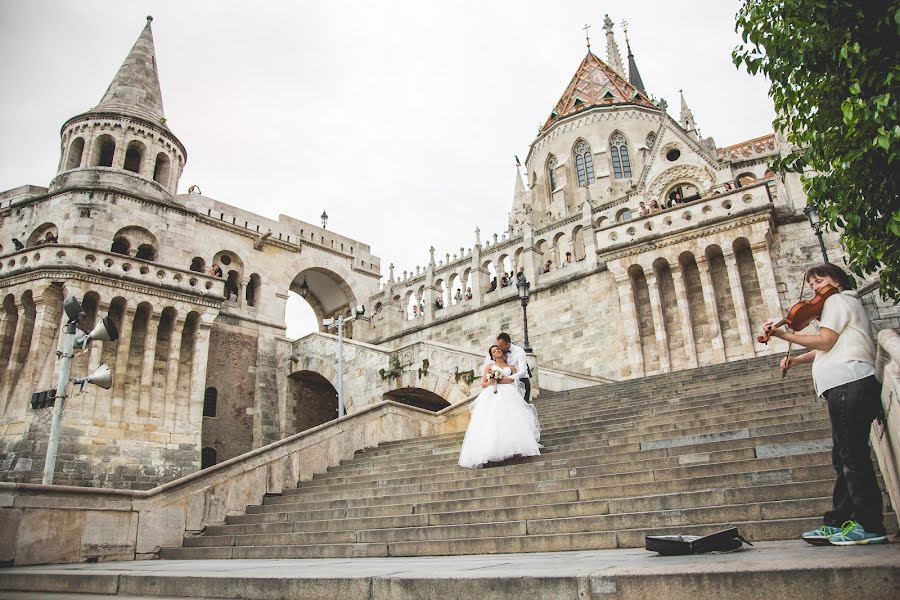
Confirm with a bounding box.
[0,0,774,333]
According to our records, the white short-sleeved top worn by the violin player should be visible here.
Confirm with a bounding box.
[813,290,875,396]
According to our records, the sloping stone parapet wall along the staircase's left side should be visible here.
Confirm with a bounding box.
[0,402,469,565]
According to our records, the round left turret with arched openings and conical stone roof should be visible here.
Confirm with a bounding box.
[50,17,187,202]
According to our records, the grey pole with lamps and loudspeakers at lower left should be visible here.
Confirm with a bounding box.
[38,296,119,485]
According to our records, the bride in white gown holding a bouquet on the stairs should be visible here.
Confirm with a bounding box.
[459,346,541,469]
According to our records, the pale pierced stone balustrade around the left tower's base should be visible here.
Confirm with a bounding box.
[0,244,225,301]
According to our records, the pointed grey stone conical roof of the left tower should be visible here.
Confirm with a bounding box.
[90,17,165,126]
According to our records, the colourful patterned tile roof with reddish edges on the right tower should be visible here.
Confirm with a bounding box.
[542,51,657,131]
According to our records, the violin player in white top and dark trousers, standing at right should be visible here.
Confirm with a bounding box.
[763,263,888,546]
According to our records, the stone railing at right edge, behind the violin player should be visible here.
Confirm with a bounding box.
[871,329,900,528]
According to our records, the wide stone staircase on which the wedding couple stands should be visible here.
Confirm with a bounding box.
[160,357,896,559]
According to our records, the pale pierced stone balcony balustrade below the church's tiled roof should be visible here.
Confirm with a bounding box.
[597,182,772,253]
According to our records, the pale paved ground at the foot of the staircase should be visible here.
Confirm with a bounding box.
[0,541,900,600]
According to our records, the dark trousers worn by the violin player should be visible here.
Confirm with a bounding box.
[824,375,885,533]
